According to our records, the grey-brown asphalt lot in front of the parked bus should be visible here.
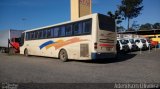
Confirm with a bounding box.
[0,49,160,83]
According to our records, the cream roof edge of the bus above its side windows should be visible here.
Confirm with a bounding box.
[25,13,99,32]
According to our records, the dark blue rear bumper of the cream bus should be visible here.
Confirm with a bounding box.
[91,53,117,60]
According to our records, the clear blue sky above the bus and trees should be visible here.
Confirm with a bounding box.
[0,0,160,30]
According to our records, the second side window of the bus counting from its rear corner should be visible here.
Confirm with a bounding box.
[73,22,83,35]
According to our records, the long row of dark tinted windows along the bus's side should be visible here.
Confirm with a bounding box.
[26,19,92,40]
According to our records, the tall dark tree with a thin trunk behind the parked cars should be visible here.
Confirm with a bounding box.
[119,0,143,29]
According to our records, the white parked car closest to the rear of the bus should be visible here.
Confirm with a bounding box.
[117,39,129,52]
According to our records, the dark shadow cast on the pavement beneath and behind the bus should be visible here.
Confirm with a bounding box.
[71,53,137,64]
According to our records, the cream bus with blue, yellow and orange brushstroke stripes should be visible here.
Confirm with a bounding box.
[20,13,117,62]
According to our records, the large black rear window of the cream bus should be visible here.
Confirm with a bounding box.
[98,14,115,32]
